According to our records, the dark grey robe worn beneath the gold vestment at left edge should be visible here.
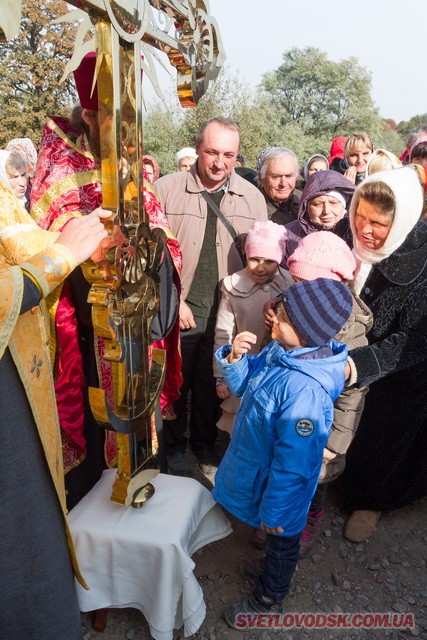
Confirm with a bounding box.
[0,277,83,640]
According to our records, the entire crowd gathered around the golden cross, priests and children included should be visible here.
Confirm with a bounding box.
[0,48,427,640]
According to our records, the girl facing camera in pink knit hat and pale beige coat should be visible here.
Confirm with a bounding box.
[214,221,293,434]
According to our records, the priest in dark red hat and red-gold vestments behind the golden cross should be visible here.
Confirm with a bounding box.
[31,53,181,500]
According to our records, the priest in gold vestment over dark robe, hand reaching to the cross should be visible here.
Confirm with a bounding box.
[0,181,110,640]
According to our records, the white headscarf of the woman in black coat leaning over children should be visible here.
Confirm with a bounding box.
[350,167,423,293]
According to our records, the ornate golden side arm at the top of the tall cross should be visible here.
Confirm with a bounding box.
[64,0,225,107]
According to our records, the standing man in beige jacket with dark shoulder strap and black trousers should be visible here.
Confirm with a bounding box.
[155,118,267,475]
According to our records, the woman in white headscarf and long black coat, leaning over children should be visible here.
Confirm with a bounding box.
[344,167,427,542]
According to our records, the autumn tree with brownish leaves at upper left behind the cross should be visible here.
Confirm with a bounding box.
[0,0,77,146]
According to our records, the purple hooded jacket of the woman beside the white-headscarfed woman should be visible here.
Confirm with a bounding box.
[284,171,356,266]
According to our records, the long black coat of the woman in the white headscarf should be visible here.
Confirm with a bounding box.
[344,220,427,511]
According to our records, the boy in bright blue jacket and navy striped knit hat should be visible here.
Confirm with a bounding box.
[212,278,353,630]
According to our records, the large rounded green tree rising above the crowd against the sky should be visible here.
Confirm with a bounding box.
[262,47,381,144]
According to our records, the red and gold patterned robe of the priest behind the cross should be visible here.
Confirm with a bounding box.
[31,118,182,471]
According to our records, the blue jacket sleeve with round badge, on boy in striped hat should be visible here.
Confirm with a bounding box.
[259,387,333,536]
